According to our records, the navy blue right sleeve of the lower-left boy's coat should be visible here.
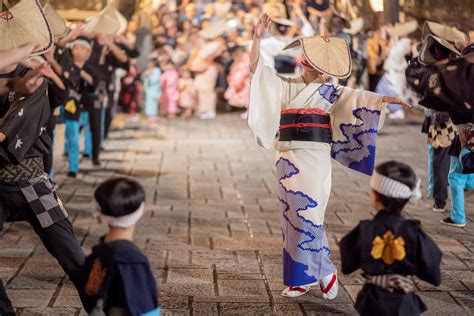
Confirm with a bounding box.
[116,263,158,316]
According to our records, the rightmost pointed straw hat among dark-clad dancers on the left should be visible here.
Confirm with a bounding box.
[84,4,124,36]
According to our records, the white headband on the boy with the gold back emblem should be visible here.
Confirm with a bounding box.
[370,171,421,200]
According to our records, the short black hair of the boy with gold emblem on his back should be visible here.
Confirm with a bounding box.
[375,160,417,213]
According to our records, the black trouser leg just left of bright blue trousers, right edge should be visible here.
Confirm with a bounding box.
[433,147,451,208]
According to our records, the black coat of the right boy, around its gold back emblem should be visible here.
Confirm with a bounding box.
[340,211,441,316]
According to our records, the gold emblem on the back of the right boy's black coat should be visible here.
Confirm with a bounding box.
[370,230,406,265]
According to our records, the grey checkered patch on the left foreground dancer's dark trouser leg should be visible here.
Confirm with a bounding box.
[18,174,68,228]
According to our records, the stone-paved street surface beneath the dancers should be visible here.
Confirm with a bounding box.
[0,114,474,316]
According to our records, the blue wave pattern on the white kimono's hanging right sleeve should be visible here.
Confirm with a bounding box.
[331,108,380,175]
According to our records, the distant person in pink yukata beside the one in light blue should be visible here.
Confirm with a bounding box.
[160,60,179,119]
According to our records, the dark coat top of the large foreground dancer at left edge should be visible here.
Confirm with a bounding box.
[0,66,51,167]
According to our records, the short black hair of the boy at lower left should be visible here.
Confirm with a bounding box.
[94,177,145,217]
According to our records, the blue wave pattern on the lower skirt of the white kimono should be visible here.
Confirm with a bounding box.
[276,158,335,286]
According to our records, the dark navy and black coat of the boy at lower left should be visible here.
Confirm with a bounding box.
[82,240,158,315]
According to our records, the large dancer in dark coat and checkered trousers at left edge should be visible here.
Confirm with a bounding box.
[0,66,84,315]
